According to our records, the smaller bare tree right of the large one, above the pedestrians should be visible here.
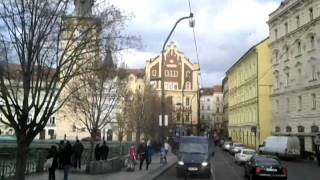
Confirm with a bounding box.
[66,66,124,161]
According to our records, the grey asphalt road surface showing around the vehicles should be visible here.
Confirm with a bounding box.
[157,148,320,180]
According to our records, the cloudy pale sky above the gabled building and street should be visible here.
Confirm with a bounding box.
[110,0,281,87]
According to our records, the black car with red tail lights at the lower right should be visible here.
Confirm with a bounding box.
[244,155,288,180]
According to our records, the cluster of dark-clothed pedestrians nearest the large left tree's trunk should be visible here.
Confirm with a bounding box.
[47,140,84,180]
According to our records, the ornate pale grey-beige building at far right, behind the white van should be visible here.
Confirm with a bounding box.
[268,0,320,153]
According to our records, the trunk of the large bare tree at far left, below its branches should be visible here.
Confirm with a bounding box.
[15,141,29,180]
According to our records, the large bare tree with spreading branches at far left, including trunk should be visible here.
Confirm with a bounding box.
[0,0,134,180]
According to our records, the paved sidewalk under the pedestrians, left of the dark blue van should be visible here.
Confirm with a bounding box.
[26,152,177,180]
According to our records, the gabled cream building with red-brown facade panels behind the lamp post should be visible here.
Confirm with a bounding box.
[145,43,200,134]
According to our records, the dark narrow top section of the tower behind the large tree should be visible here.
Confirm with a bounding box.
[74,0,94,17]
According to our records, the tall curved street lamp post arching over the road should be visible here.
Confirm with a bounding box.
[160,13,194,141]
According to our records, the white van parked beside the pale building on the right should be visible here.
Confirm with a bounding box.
[259,136,300,158]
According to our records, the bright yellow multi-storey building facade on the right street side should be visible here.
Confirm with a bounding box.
[227,39,271,148]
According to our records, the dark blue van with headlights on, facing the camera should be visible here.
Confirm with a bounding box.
[176,136,214,177]
